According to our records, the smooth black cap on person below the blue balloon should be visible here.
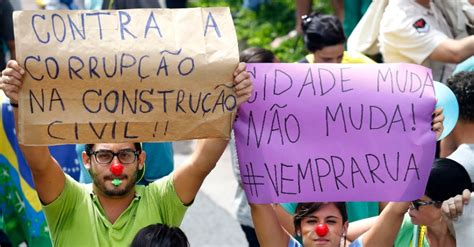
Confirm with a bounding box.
[425,159,472,206]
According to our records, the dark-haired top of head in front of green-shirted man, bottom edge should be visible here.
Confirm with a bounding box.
[130,224,189,247]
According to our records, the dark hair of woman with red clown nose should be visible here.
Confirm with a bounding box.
[293,202,348,232]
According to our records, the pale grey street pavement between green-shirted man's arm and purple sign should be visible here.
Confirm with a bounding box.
[175,142,248,247]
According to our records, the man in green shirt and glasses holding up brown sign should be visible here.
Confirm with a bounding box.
[0,61,253,246]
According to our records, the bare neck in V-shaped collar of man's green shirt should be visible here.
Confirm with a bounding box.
[94,187,135,224]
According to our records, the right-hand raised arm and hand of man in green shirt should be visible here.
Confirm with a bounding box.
[173,63,253,205]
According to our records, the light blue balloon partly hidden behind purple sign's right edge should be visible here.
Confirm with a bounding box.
[433,81,459,141]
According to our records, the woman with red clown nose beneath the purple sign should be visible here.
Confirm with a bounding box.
[250,202,362,247]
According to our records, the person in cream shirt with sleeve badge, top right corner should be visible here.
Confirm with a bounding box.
[378,0,474,82]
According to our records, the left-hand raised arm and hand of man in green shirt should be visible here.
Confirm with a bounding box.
[0,60,65,204]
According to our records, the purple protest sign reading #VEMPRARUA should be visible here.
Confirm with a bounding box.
[234,64,435,203]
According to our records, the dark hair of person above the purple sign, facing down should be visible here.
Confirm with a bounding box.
[301,12,346,52]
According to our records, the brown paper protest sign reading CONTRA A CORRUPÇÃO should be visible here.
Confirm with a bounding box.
[14,8,238,145]
